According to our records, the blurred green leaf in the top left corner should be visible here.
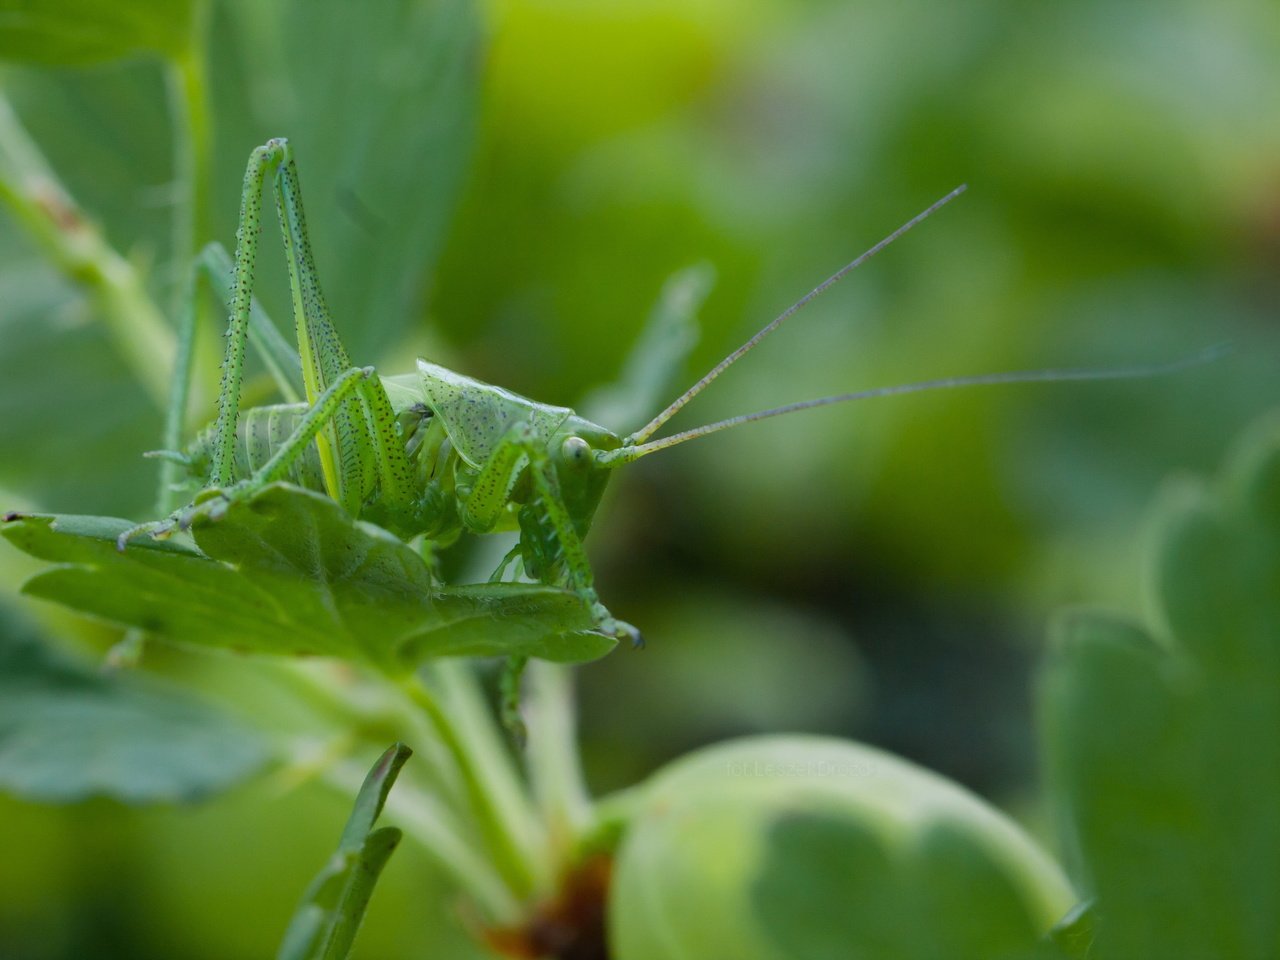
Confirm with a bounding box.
[0,0,192,64]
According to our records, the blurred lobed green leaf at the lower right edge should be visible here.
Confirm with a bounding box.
[1043,424,1280,960]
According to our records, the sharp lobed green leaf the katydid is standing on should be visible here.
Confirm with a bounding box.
[4,484,616,673]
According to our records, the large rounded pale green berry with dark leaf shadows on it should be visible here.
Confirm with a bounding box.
[609,736,1073,960]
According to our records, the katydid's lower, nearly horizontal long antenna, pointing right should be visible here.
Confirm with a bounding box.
[596,343,1231,466]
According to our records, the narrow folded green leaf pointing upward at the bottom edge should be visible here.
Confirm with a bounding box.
[276,744,413,960]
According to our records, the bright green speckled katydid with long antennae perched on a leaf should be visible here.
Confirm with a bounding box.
[118,140,1218,644]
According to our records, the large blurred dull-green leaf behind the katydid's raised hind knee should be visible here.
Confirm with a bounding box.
[211,0,481,363]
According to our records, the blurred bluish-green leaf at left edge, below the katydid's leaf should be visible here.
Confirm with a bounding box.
[0,609,266,804]
